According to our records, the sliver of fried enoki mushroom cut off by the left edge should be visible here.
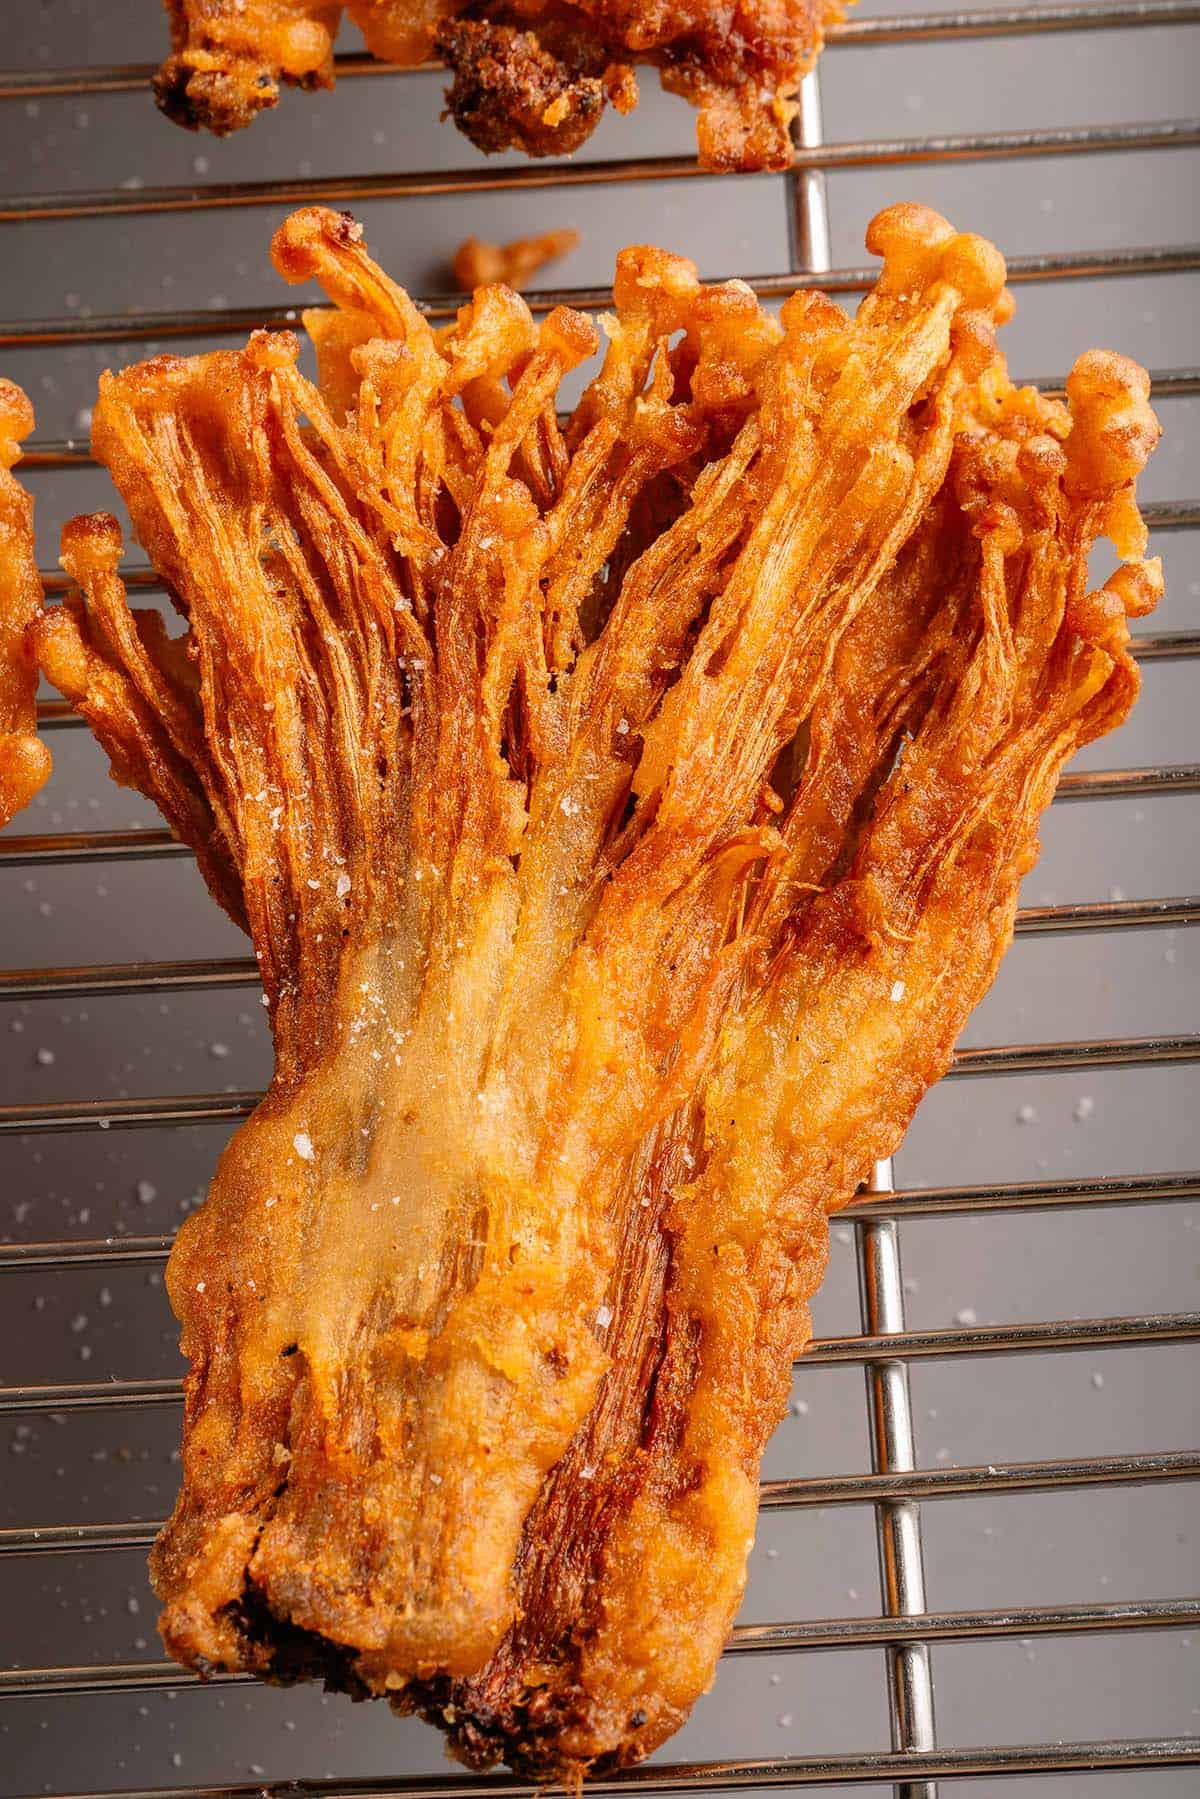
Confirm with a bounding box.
[0,380,50,826]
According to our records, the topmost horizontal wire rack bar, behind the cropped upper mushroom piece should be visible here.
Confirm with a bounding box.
[0,0,1200,101]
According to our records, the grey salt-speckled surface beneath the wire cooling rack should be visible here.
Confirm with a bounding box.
[0,0,1200,1799]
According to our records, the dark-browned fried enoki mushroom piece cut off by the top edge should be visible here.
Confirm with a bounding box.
[155,0,842,169]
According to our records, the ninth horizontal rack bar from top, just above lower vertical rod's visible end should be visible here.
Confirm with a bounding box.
[0,1033,1200,1135]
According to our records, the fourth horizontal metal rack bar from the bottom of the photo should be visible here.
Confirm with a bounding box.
[0,1309,1200,1418]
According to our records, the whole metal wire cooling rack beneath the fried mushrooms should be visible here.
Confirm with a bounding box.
[0,0,1200,1799]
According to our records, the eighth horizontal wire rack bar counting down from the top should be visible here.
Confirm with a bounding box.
[0,894,1200,1000]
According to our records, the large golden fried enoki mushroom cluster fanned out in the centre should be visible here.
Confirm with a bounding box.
[38,207,1160,1779]
